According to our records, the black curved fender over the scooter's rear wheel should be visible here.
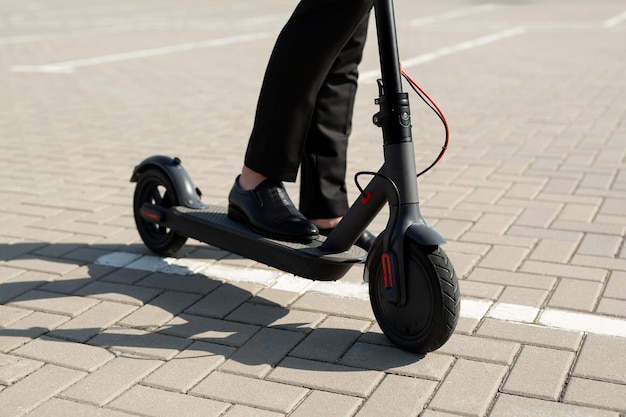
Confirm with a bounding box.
[130,155,207,209]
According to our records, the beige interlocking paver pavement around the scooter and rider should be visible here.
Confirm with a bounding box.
[0,0,626,417]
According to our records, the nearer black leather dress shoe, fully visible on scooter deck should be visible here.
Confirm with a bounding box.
[228,177,319,242]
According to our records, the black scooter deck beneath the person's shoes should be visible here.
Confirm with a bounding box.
[167,205,367,281]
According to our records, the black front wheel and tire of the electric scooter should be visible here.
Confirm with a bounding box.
[365,236,461,353]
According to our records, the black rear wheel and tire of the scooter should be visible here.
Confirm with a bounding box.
[133,168,187,256]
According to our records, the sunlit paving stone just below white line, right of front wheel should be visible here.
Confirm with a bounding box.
[476,319,582,352]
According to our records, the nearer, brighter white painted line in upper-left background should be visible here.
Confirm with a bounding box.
[11,32,269,73]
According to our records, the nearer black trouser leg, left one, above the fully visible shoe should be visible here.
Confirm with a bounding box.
[245,0,372,181]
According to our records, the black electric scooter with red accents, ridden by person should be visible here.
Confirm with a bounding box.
[131,0,460,353]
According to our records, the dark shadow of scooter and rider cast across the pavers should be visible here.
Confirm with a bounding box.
[0,242,424,372]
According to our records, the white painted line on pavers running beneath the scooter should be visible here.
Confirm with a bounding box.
[95,252,626,337]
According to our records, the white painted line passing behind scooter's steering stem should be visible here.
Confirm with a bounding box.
[359,26,526,83]
